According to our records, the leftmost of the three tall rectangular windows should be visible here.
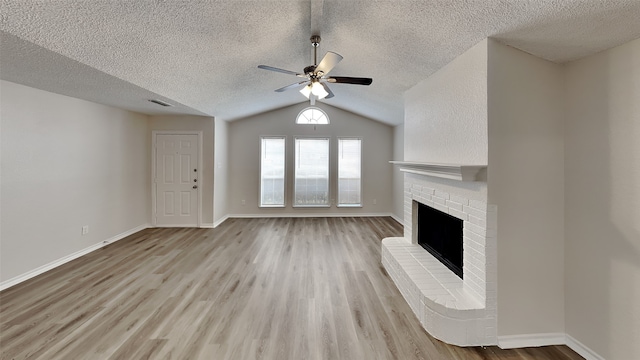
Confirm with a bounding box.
[260,136,285,207]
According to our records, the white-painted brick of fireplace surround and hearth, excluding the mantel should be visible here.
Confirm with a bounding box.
[396,174,497,345]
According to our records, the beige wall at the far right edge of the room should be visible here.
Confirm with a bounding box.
[565,39,640,360]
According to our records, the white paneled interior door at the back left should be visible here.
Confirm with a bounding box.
[154,134,200,226]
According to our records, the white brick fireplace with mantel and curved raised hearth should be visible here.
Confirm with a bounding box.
[382,162,497,346]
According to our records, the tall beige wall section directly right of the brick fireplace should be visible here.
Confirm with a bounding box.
[487,40,564,338]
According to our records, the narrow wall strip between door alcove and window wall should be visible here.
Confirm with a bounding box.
[213,120,229,225]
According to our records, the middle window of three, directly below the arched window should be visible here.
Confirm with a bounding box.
[294,138,330,206]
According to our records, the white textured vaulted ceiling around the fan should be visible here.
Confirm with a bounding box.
[0,0,640,125]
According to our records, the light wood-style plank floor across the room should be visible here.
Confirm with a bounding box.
[0,218,582,360]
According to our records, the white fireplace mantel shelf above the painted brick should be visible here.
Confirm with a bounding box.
[389,160,487,181]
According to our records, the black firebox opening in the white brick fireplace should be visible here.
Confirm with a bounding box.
[417,203,463,279]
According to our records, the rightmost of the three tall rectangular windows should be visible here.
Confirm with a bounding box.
[338,138,362,206]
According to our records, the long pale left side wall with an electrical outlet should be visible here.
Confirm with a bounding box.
[0,81,151,283]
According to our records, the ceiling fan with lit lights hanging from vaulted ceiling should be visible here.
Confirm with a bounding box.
[258,35,373,105]
